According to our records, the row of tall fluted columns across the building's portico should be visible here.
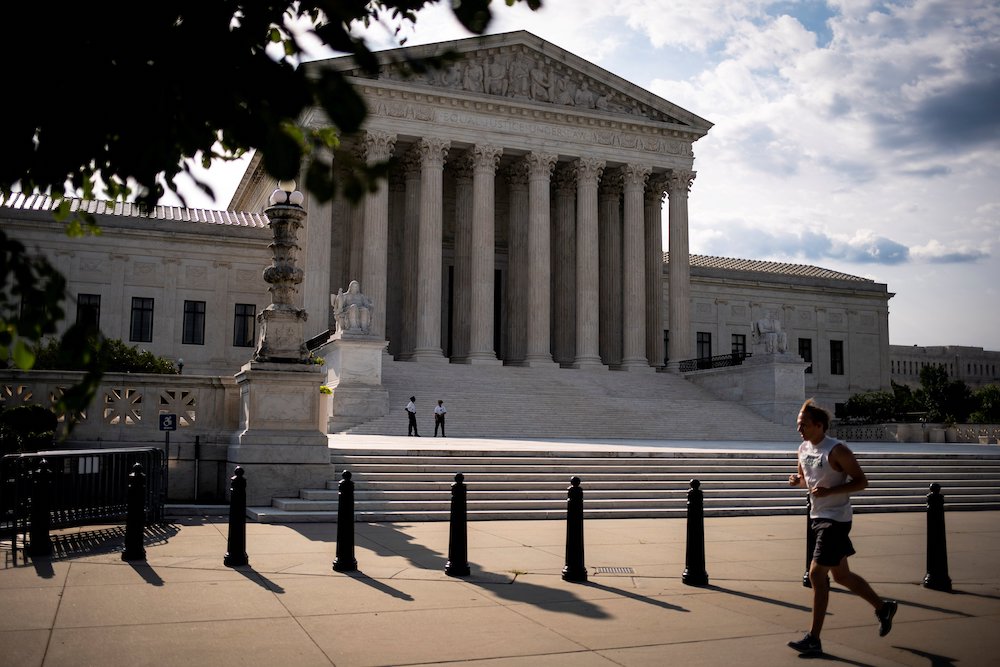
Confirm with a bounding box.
[347,131,694,370]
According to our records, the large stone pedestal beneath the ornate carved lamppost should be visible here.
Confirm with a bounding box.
[227,361,335,505]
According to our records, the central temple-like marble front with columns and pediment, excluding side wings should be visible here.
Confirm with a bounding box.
[234,32,711,371]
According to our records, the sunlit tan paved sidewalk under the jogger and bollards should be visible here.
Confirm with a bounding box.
[0,512,1000,667]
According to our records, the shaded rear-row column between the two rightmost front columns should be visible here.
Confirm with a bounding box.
[643,174,667,368]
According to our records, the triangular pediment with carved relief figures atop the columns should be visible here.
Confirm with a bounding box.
[326,31,712,134]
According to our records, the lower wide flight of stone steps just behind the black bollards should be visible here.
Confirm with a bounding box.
[250,448,1000,523]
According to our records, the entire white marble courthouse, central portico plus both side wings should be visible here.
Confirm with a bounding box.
[0,32,892,412]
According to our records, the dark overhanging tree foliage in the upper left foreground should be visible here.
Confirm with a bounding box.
[0,0,541,422]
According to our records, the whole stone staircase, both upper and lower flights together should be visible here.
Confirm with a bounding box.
[248,361,1000,523]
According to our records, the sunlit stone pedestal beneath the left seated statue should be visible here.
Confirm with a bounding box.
[324,332,389,432]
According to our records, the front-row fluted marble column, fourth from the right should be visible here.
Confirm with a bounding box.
[525,153,557,366]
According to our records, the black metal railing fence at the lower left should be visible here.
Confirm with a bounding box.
[0,447,167,553]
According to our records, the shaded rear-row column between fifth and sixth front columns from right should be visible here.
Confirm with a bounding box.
[449,151,475,363]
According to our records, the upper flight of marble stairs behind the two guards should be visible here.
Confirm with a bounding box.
[346,360,797,442]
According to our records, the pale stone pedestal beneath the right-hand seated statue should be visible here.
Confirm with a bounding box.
[740,354,809,426]
